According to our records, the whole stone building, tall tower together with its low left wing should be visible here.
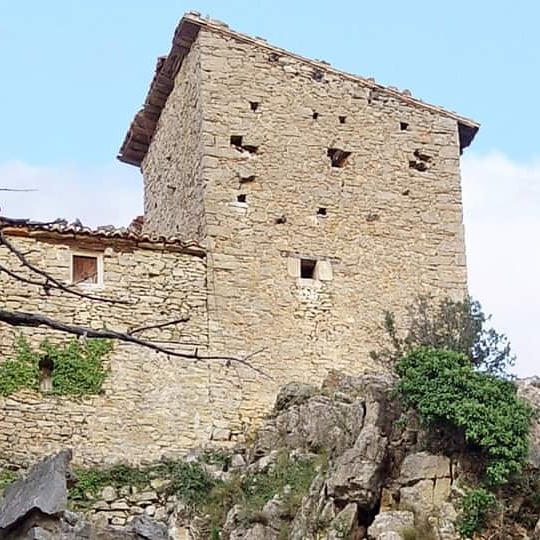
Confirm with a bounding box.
[0,13,478,462]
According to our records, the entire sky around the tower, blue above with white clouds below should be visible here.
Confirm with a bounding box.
[0,0,540,374]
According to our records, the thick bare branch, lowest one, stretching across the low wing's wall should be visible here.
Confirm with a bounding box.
[0,309,272,379]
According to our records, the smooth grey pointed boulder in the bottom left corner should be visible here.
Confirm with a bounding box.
[0,450,71,534]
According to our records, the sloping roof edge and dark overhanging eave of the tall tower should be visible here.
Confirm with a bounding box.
[118,12,480,166]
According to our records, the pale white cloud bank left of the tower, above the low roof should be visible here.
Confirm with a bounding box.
[0,162,143,226]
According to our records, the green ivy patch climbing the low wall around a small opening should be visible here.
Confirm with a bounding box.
[0,336,112,396]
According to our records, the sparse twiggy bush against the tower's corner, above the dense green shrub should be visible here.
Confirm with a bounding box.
[371,296,515,375]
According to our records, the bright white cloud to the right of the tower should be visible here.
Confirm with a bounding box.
[462,152,540,376]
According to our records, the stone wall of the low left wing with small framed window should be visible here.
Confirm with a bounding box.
[0,234,215,465]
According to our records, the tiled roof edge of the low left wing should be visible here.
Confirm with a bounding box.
[0,216,206,256]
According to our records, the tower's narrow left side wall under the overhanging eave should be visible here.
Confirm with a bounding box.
[141,38,205,240]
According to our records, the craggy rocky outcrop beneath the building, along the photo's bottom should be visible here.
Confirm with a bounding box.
[6,373,540,540]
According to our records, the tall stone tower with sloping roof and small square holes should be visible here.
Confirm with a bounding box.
[119,13,478,393]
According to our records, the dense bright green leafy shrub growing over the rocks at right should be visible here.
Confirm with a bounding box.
[396,347,532,485]
